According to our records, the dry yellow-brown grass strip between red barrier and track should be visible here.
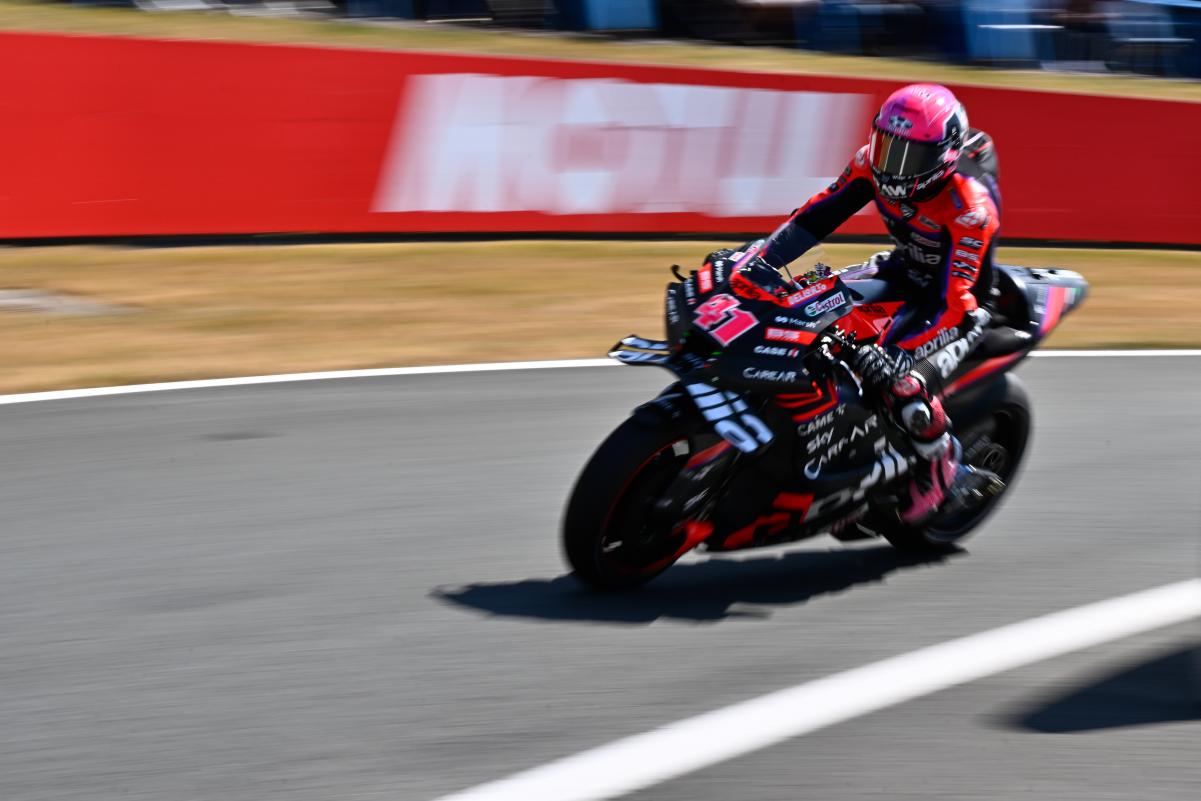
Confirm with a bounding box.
[0,241,1201,391]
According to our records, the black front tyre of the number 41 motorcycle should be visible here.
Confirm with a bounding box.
[562,418,692,590]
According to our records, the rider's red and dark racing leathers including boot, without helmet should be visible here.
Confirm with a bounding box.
[764,131,999,525]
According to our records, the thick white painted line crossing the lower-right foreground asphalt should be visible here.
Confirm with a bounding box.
[427,579,1201,801]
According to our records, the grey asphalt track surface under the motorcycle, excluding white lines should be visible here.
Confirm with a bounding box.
[0,358,1201,801]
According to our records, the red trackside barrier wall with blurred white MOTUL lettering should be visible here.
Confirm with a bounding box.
[0,34,1201,244]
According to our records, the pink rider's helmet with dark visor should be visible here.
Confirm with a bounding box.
[870,83,968,201]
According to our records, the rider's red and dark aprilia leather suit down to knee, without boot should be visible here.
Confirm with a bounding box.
[765,130,1000,449]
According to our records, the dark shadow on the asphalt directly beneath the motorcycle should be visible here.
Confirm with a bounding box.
[431,545,966,624]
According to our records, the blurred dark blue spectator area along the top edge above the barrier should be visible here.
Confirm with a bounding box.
[100,0,1201,77]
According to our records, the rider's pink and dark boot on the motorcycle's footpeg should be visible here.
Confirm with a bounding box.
[901,434,1005,526]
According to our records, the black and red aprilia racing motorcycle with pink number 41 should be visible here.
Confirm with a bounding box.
[562,245,1088,590]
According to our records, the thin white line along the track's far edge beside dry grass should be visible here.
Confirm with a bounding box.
[0,351,1201,406]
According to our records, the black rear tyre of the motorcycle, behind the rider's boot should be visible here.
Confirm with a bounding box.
[877,376,1032,552]
